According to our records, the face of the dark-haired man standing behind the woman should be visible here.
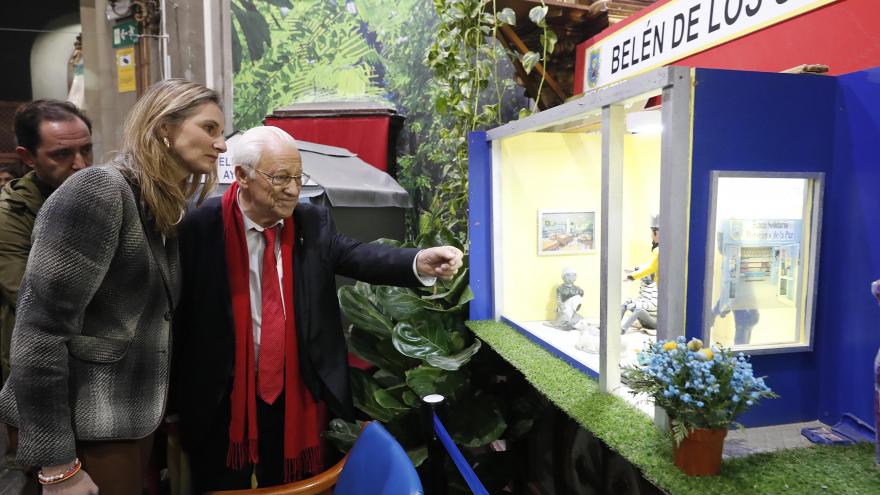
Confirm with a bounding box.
[15,118,92,187]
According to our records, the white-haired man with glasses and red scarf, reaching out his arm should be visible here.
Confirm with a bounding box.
[173,127,462,493]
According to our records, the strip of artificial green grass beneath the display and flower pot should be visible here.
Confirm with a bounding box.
[468,321,880,495]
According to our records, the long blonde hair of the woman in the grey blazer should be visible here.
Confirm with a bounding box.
[122,79,220,235]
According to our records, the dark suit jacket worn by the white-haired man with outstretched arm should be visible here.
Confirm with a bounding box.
[172,197,419,448]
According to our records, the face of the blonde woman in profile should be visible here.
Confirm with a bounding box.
[164,103,226,174]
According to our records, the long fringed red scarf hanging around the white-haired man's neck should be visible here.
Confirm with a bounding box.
[222,183,323,482]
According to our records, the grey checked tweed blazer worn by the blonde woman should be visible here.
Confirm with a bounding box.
[0,166,179,466]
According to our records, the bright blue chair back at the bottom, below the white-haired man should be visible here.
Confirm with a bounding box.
[333,421,424,495]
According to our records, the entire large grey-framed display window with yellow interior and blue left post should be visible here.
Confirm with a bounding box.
[469,67,693,422]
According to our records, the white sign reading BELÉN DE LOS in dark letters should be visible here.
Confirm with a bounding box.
[583,0,840,91]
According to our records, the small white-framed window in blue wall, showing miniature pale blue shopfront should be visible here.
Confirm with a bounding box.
[703,172,823,354]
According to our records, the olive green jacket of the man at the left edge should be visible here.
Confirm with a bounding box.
[0,171,52,381]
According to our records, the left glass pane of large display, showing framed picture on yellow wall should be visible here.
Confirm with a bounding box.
[496,126,602,369]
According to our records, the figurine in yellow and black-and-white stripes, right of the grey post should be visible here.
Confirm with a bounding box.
[620,215,660,335]
